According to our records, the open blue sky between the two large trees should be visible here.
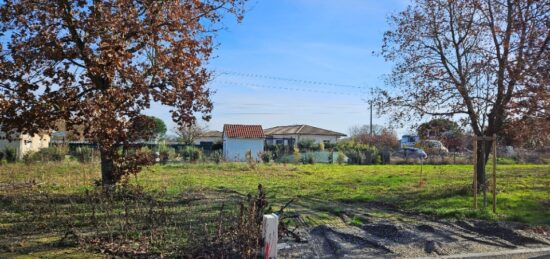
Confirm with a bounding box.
[148,0,414,137]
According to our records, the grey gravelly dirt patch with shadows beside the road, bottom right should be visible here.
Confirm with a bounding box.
[280,204,550,258]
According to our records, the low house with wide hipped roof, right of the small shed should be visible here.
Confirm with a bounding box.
[264,125,346,146]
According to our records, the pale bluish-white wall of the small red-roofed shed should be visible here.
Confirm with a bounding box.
[223,138,264,161]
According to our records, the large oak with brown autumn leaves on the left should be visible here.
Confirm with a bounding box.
[0,0,245,186]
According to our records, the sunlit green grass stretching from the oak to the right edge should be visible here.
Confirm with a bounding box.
[132,164,550,224]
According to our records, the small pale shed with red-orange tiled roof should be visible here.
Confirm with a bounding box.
[223,124,265,161]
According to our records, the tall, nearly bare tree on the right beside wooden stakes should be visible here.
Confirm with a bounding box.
[377,0,550,191]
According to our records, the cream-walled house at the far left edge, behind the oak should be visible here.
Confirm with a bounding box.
[0,132,51,159]
